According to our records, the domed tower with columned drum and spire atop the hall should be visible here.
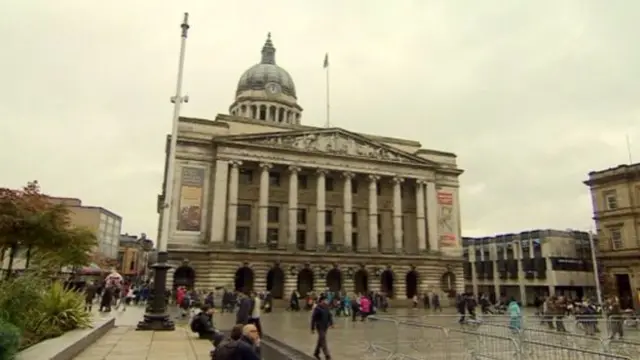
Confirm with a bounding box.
[229,33,302,125]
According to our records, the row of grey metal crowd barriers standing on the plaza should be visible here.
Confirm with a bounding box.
[363,316,640,360]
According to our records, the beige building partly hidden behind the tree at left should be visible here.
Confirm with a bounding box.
[2,197,122,271]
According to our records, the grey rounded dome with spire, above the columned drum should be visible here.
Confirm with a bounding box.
[236,33,296,98]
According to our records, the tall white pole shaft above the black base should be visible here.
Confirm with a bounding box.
[158,13,189,252]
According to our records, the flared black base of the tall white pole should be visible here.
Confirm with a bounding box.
[136,251,176,331]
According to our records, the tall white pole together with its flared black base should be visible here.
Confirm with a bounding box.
[136,13,189,331]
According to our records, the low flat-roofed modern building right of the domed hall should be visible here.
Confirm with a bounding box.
[462,230,597,304]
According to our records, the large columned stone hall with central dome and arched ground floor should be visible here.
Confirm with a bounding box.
[159,37,464,299]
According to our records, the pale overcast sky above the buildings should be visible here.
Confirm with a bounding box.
[0,0,640,237]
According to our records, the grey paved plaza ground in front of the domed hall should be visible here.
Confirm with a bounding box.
[76,307,640,360]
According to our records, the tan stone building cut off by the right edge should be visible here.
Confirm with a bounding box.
[584,163,640,306]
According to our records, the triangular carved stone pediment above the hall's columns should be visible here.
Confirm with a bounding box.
[215,128,436,165]
